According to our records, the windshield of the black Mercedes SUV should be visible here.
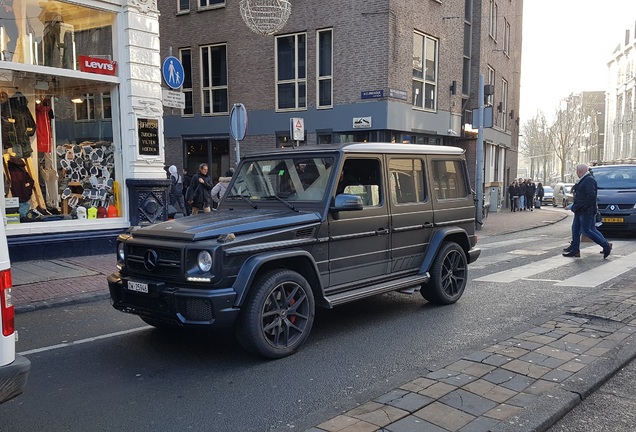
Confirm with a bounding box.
[226,156,334,201]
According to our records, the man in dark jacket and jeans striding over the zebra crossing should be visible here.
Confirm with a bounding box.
[563,164,612,259]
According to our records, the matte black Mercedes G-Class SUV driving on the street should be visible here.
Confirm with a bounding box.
[108,143,480,358]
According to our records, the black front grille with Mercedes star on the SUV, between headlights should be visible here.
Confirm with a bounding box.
[126,245,181,277]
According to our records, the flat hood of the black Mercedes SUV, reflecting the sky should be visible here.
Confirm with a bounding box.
[133,209,320,241]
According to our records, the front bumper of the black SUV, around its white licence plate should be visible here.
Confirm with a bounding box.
[108,273,240,327]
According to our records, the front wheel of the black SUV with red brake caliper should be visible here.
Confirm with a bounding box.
[236,269,315,359]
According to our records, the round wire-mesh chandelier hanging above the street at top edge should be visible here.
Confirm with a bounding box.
[239,0,291,36]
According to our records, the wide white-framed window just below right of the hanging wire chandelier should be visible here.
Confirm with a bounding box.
[276,33,307,111]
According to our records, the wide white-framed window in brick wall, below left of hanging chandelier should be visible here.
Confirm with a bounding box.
[201,45,228,114]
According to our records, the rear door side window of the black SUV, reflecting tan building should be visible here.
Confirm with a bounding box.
[389,159,428,204]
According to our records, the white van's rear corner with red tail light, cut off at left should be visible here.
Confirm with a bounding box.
[0,218,31,403]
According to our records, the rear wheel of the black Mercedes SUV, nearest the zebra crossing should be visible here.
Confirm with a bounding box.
[420,242,468,304]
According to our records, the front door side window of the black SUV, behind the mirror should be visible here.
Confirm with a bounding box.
[336,158,382,206]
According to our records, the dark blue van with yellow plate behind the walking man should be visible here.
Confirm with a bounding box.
[592,165,636,232]
